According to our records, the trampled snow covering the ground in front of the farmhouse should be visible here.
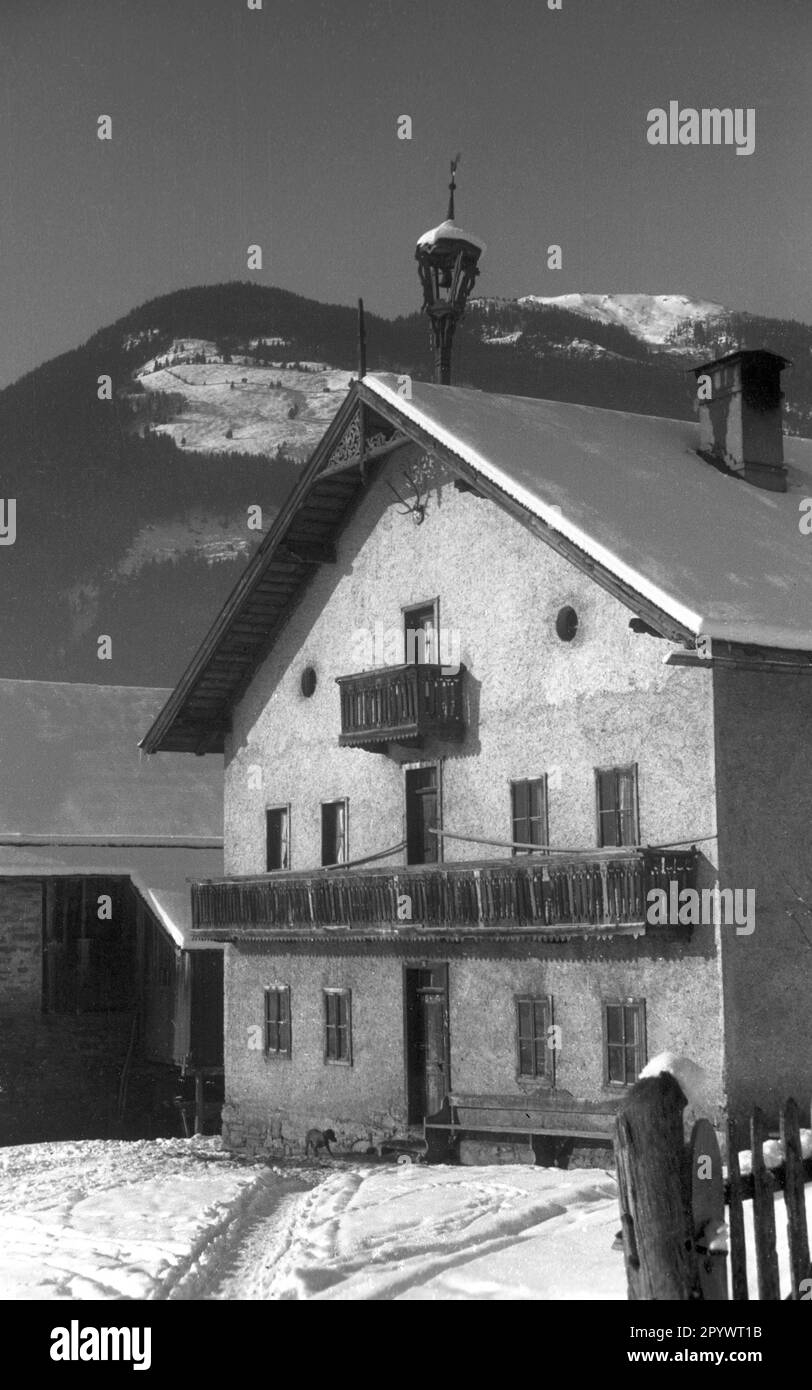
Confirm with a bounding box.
[0,1138,812,1301]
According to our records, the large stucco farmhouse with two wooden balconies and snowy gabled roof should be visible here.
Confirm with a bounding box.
[143,333,812,1152]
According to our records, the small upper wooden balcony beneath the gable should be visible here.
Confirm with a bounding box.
[336,664,464,752]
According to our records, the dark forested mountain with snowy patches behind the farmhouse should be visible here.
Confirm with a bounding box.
[0,282,812,685]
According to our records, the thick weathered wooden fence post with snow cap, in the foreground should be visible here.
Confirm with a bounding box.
[615,1072,702,1302]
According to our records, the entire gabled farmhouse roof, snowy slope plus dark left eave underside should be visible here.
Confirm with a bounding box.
[143,374,812,752]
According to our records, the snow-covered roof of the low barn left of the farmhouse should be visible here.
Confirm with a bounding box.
[0,680,222,945]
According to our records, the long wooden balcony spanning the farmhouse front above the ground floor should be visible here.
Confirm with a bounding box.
[192,849,697,941]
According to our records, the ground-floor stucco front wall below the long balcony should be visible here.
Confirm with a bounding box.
[224,941,722,1152]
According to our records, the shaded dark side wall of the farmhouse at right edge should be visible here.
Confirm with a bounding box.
[713,670,812,1118]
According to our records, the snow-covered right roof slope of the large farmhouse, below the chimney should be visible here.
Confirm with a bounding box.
[364,374,812,651]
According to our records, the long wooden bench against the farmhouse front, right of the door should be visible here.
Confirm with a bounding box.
[423,1090,620,1156]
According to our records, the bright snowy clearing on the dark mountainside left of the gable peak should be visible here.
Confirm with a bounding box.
[138,339,352,457]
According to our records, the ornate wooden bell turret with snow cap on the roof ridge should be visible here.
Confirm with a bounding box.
[414,156,485,386]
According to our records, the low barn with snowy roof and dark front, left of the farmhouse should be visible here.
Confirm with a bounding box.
[0,680,222,1144]
